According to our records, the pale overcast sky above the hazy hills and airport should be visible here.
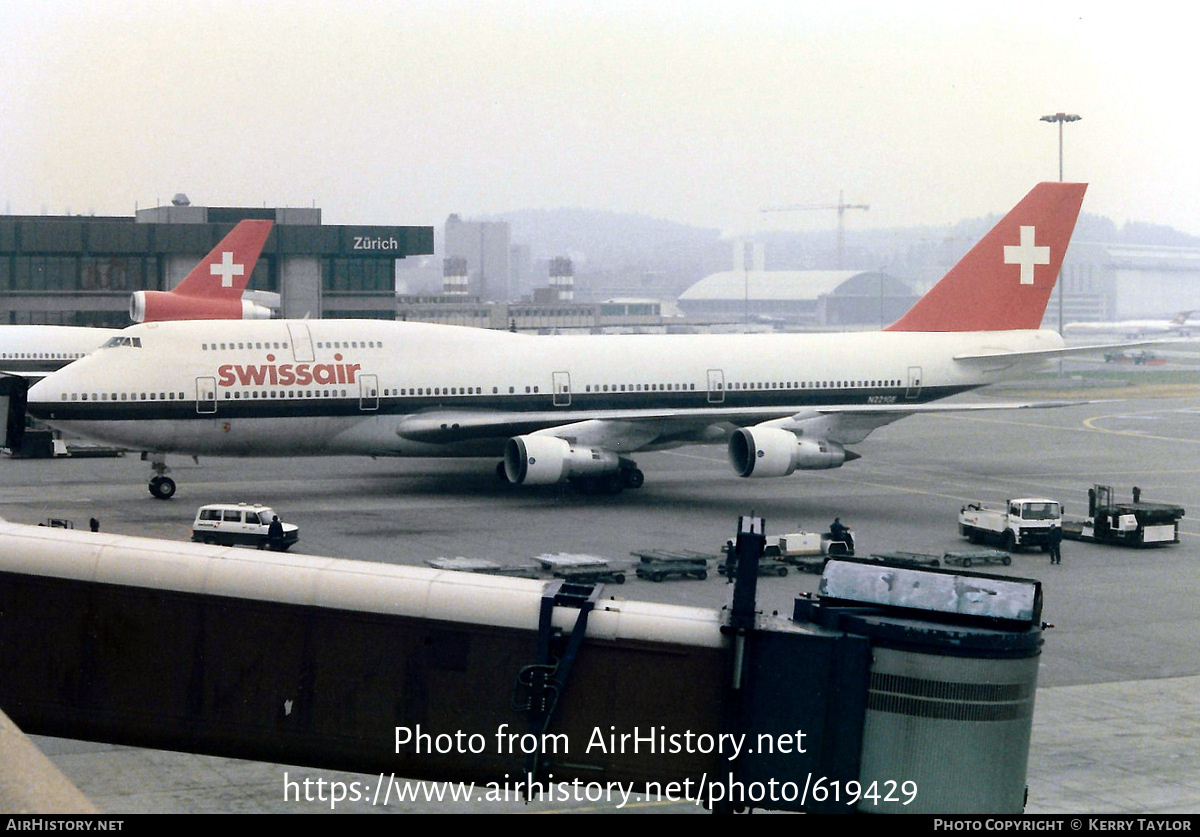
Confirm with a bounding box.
[0,0,1200,235]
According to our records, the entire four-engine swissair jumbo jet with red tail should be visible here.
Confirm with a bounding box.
[21,182,1086,498]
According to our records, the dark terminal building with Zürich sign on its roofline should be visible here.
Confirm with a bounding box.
[0,195,433,327]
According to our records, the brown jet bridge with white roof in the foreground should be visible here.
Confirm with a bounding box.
[0,518,1042,814]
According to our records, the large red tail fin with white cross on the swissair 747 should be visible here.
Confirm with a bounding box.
[886,183,1087,331]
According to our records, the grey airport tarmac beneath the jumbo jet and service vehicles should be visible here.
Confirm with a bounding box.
[0,395,1200,813]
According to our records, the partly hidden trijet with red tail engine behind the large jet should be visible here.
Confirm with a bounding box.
[0,219,275,378]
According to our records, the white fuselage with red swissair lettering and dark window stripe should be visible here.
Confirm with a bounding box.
[29,320,1062,456]
